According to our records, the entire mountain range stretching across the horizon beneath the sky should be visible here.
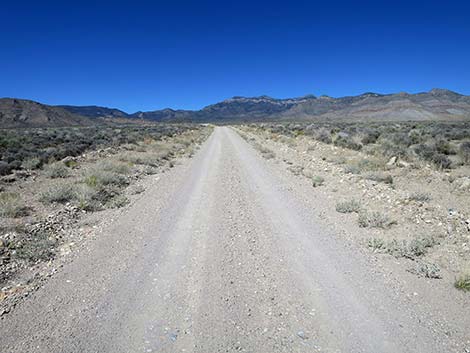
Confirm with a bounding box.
[0,89,470,127]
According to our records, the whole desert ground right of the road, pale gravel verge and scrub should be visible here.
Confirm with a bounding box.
[238,121,470,291]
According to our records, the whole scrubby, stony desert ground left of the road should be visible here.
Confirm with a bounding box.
[0,124,211,296]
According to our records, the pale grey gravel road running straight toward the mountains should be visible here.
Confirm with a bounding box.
[0,128,462,353]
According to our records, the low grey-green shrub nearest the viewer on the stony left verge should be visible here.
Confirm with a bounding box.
[15,232,57,262]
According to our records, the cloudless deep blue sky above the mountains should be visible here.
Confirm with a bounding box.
[0,0,470,112]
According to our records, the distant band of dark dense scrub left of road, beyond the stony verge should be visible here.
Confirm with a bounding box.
[0,124,198,178]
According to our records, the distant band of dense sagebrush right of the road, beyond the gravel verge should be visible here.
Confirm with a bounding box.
[244,122,470,171]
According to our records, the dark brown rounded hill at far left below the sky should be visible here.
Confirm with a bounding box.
[0,98,93,128]
